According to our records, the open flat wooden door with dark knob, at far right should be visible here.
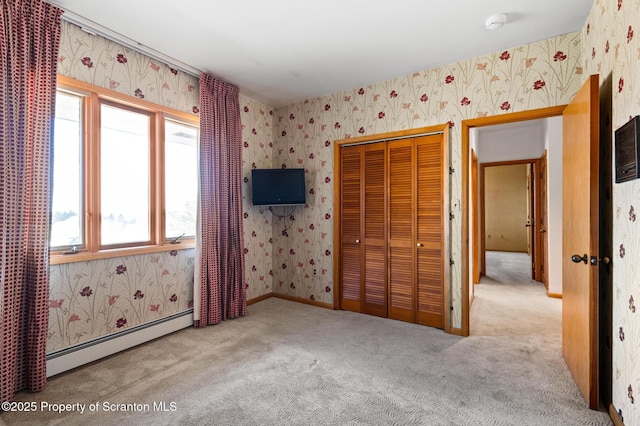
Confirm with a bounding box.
[562,76,599,409]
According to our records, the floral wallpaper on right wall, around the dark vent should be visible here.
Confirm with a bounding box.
[582,0,640,425]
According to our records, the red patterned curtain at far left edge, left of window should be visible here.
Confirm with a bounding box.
[0,0,62,402]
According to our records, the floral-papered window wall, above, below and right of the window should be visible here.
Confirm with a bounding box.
[47,21,272,352]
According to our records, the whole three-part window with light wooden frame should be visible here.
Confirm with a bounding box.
[50,76,199,263]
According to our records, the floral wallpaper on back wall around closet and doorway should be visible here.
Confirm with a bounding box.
[273,33,583,322]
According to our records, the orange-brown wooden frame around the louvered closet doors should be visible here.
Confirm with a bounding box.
[333,123,452,333]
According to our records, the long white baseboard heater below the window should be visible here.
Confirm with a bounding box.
[47,309,193,377]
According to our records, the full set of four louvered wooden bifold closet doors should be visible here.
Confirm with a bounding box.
[339,133,448,328]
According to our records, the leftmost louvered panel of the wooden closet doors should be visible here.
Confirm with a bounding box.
[340,146,364,312]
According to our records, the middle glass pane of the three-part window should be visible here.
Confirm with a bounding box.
[100,105,151,246]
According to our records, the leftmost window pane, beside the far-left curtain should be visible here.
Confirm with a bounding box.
[49,91,84,249]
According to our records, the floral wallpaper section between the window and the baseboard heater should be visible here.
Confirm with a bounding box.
[47,250,194,352]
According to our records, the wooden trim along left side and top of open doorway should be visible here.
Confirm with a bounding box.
[462,105,566,336]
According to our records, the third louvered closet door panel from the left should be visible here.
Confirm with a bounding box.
[388,139,416,322]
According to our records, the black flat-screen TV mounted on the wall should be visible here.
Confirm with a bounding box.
[251,169,307,206]
